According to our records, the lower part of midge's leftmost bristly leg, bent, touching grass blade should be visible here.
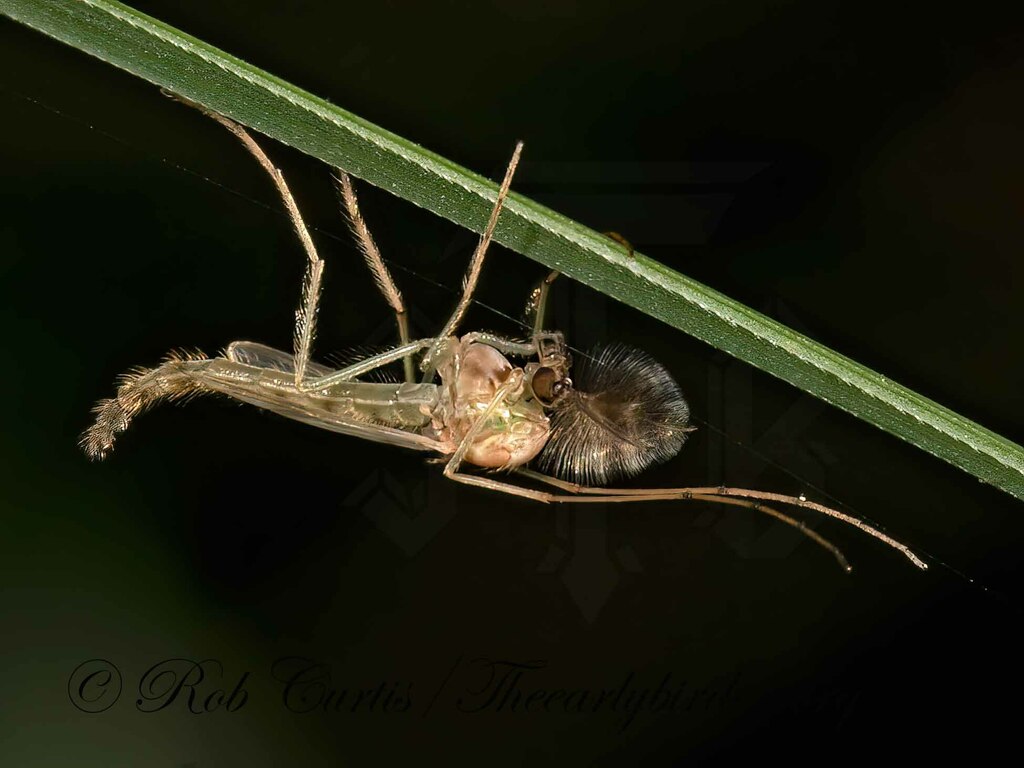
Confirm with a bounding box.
[168,93,324,386]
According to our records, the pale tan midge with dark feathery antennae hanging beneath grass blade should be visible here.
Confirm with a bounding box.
[81,96,927,571]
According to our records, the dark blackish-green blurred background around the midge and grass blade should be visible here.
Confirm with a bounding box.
[0,0,1024,767]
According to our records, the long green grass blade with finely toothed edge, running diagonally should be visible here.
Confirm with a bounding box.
[0,0,1024,500]
